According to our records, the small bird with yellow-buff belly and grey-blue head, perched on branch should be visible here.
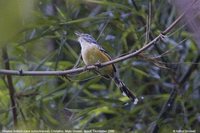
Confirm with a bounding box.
[75,32,138,104]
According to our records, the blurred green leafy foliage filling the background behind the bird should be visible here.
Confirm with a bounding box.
[0,0,200,133]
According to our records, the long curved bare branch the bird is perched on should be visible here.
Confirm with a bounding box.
[0,3,185,76]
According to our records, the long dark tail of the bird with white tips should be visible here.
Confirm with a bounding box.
[113,76,138,104]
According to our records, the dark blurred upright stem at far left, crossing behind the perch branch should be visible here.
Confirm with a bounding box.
[2,46,17,126]
